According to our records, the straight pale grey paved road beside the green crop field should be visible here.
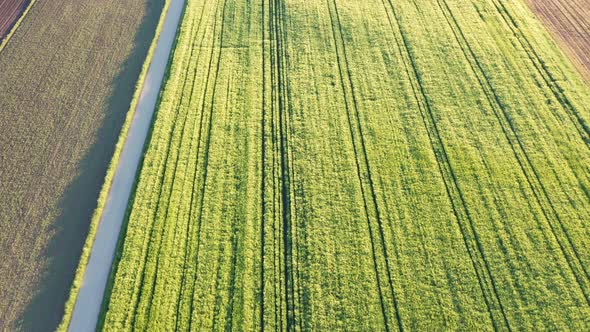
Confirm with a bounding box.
[69,0,184,331]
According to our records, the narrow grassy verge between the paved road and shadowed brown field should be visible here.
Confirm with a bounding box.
[56,0,170,331]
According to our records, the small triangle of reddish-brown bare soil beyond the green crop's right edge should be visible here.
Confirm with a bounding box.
[528,0,590,79]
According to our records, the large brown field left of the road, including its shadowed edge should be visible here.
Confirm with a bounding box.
[0,0,164,331]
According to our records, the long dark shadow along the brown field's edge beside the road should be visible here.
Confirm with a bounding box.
[17,0,164,331]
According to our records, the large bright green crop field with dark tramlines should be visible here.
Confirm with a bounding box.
[100,0,590,331]
